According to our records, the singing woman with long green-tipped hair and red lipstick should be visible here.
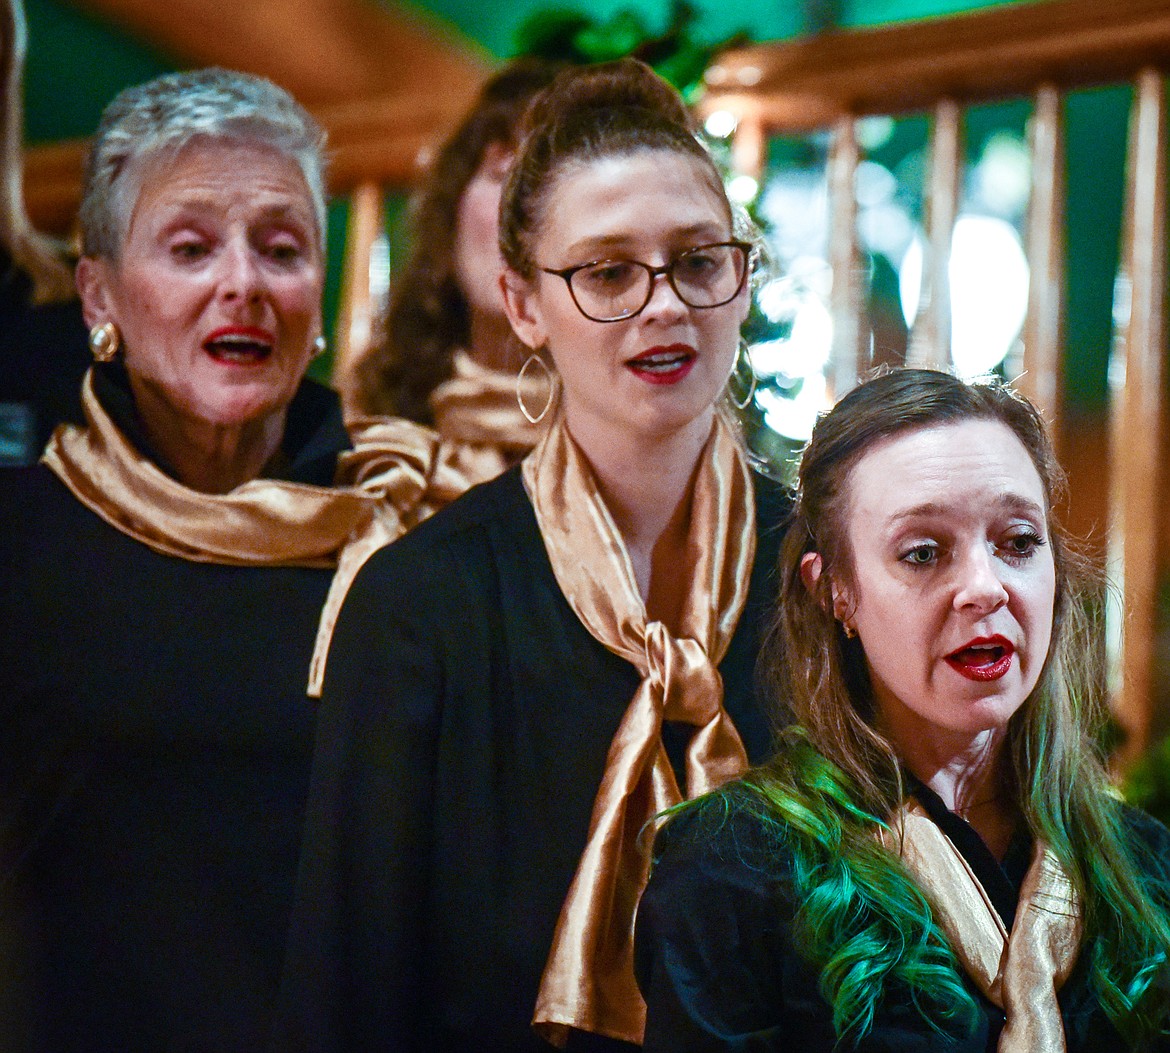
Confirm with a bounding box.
[636,370,1170,1053]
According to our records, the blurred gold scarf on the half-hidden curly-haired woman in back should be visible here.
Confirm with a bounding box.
[431,351,549,483]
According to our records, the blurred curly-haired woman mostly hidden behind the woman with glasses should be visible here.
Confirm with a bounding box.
[353,59,560,482]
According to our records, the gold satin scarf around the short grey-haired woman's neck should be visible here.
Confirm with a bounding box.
[41,374,467,696]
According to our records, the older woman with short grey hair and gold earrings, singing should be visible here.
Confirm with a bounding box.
[0,70,457,1053]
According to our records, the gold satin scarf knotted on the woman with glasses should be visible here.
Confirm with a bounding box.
[522,417,756,1046]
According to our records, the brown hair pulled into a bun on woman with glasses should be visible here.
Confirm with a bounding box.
[500,59,732,278]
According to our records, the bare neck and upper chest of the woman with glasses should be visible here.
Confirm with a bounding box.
[566,411,714,627]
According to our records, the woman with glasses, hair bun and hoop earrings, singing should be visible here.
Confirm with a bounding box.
[277,60,789,1053]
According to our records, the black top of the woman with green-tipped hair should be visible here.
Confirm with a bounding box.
[635,784,1170,1053]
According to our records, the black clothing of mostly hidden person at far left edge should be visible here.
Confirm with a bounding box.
[0,248,91,464]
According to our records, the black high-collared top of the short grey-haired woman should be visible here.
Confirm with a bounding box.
[0,366,349,1053]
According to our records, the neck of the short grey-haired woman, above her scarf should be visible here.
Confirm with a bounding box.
[130,373,288,494]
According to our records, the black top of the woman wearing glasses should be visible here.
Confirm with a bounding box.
[275,468,789,1053]
